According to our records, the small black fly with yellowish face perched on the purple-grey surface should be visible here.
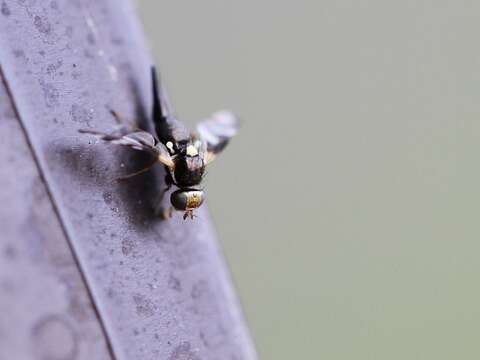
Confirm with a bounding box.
[79,67,239,220]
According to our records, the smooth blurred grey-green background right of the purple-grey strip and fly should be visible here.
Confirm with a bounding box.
[137,0,480,360]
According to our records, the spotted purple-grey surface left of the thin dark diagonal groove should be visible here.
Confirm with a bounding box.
[0,70,111,360]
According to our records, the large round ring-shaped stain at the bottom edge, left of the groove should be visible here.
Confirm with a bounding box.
[31,315,78,360]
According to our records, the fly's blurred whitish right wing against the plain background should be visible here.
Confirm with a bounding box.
[197,110,240,163]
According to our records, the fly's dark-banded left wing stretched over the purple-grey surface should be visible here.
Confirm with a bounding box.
[79,127,173,167]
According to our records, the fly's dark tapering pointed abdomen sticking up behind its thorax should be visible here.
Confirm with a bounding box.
[151,66,190,144]
